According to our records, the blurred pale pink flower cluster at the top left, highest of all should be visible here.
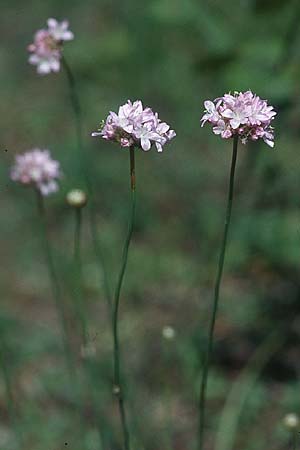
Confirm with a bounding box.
[28,19,74,75]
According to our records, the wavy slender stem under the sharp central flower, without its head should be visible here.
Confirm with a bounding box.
[113,147,136,450]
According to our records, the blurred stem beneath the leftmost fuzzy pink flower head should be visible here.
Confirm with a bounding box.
[36,190,73,374]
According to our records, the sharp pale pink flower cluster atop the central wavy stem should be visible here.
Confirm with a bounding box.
[92,100,176,152]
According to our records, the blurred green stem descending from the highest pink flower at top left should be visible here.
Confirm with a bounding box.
[62,57,112,315]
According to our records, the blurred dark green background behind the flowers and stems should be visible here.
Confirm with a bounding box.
[0,0,300,450]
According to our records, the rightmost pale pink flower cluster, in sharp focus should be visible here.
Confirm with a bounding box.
[201,91,276,147]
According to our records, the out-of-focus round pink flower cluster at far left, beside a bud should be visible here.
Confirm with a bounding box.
[11,148,61,195]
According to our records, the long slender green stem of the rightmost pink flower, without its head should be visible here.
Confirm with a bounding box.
[198,137,238,450]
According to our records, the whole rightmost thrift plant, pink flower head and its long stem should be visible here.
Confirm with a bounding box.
[198,91,276,450]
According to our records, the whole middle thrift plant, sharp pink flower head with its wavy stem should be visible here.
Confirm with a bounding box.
[92,100,176,450]
